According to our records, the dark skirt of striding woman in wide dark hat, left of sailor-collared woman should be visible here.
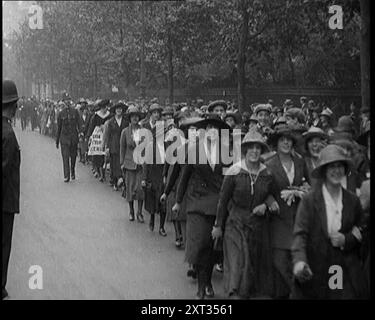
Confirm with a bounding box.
[185,212,216,266]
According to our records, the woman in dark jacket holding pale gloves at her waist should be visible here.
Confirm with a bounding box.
[265,125,309,299]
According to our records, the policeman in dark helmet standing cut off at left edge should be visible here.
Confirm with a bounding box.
[1,80,21,299]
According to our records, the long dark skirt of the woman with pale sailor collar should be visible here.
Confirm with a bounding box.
[223,217,273,298]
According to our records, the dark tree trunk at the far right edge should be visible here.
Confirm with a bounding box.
[360,0,371,108]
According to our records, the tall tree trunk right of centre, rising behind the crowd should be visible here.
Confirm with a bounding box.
[237,0,249,112]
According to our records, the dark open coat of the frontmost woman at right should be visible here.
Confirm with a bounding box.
[292,184,367,299]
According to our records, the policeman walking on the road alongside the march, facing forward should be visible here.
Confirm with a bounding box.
[56,97,82,182]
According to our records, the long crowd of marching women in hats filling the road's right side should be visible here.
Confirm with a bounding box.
[19,97,370,299]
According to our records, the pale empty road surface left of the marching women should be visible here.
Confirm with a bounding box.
[7,123,222,299]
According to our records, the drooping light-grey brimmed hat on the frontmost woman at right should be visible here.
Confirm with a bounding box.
[311,144,353,178]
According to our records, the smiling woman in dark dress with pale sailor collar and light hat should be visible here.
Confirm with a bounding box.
[212,130,279,298]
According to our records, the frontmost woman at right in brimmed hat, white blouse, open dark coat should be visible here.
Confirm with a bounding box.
[292,145,368,299]
